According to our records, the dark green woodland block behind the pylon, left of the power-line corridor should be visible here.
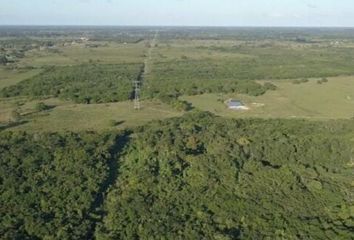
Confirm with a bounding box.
[1,64,141,103]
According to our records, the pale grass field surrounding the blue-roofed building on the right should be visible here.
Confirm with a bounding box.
[182,77,354,120]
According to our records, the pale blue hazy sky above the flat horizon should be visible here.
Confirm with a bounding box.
[0,0,354,27]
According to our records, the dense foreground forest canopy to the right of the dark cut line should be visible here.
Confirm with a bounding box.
[97,114,354,239]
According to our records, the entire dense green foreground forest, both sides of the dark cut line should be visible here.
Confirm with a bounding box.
[0,111,354,239]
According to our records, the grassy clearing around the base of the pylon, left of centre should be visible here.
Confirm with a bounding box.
[0,99,182,132]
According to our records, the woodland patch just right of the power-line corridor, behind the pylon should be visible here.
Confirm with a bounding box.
[144,61,267,99]
